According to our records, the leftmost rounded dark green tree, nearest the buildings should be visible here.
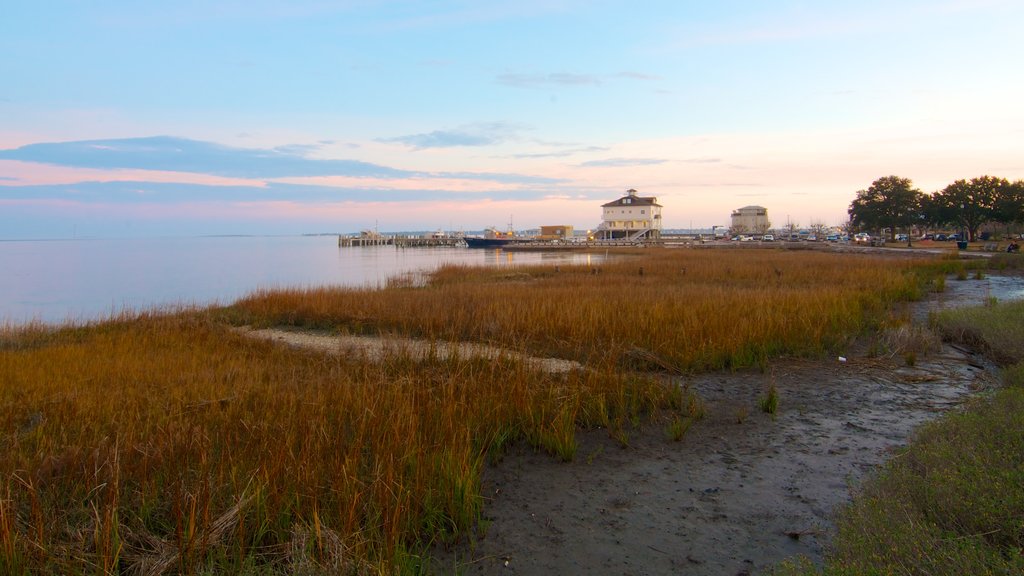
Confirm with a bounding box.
[848,176,923,242]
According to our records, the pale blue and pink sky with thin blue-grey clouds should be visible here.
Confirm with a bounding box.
[0,0,1024,239]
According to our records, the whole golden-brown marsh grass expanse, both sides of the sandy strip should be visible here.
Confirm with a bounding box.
[0,251,933,574]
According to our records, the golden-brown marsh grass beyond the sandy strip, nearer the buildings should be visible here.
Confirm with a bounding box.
[220,250,923,373]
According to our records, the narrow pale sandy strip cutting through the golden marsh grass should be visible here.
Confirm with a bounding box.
[238,327,583,373]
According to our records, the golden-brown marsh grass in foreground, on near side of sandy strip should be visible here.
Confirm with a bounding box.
[0,315,688,573]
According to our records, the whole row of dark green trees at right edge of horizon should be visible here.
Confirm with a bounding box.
[848,172,1024,241]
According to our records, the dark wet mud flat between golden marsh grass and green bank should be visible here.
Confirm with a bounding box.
[433,277,1024,575]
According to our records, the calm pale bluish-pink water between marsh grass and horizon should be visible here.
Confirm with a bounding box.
[0,236,598,323]
